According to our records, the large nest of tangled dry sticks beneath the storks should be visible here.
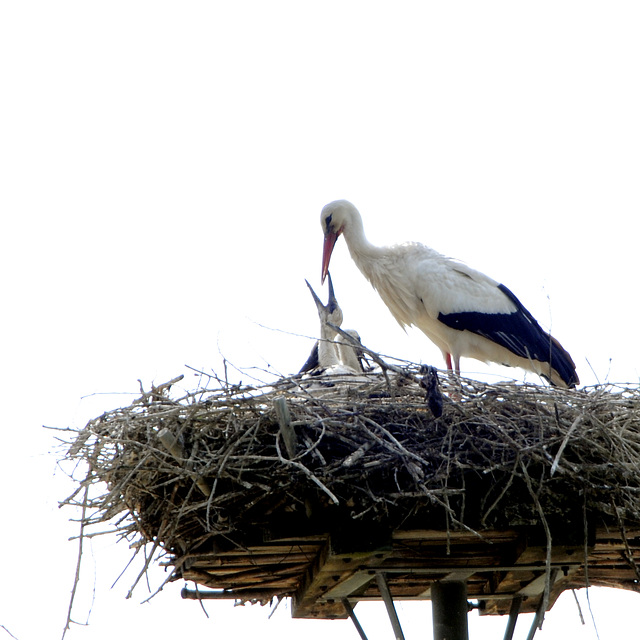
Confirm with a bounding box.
[60,366,640,596]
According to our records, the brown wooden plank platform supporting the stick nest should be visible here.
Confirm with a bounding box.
[182,529,640,619]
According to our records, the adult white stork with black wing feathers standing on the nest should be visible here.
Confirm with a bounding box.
[320,200,579,388]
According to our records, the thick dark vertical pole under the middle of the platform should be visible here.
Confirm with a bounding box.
[431,580,469,640]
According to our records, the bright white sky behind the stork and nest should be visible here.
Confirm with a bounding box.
[0,0,640,640]
